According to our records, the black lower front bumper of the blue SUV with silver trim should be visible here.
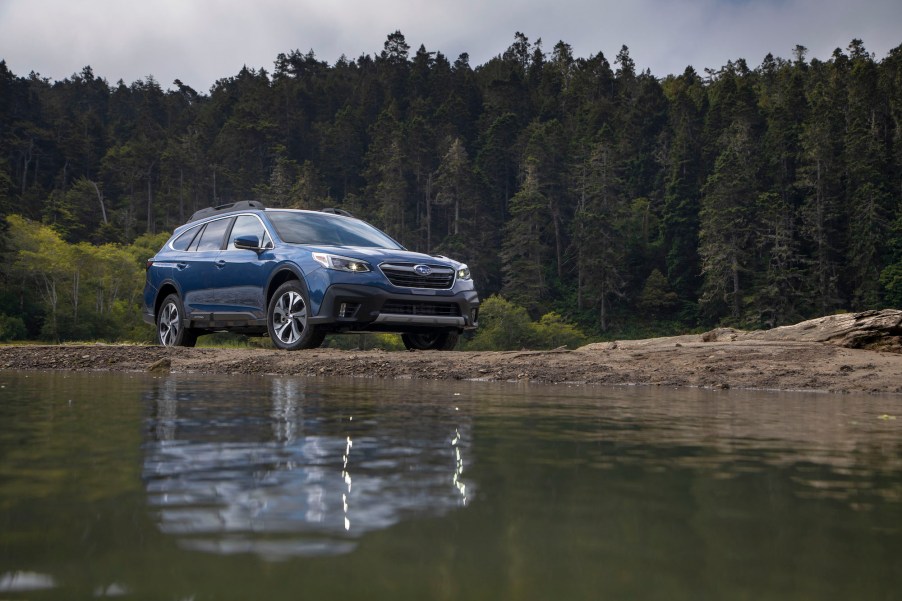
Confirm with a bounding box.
[310,284,479,332]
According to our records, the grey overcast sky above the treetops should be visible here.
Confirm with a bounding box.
[0,0,902,92]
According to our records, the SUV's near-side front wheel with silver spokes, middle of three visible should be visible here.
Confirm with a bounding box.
[266,280,326,351]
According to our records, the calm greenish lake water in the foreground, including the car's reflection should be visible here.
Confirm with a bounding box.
[0,371,902,601]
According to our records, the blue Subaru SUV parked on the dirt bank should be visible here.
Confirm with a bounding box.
[144,201,479,350]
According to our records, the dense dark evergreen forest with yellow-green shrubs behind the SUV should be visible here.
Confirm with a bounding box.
[0,31,902,346]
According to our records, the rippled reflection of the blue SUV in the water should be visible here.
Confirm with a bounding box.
[143,377,471,557]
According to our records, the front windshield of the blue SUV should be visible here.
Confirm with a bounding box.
[266,211,403,250]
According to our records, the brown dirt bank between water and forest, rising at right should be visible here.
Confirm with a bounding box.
[0,311,902,394]
